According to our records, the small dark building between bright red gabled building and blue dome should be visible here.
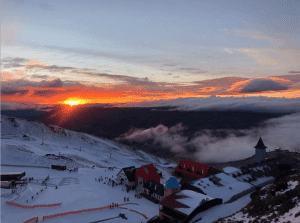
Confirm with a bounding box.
[142,180,164,203]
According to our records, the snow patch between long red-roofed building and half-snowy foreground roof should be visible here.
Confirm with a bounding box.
[193,173,252,203]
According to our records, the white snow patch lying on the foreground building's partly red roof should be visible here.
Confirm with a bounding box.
[175,190,214,215]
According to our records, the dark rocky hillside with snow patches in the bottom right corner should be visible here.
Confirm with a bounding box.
[213,172,300,223]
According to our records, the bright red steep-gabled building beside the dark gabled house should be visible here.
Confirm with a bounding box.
[135,164,160,186]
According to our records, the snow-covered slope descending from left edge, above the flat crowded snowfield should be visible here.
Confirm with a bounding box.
[1,116,172,168]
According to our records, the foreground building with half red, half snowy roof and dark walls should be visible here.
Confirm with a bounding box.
[159,190,222,223]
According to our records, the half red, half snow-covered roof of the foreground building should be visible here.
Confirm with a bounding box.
[159,190,214,215]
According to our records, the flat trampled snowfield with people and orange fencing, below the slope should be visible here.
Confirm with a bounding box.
[1,166,158,223]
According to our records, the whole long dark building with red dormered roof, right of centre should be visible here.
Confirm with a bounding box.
[175,159,222,185]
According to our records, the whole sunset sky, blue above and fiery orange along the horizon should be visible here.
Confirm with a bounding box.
[0,0,300,108]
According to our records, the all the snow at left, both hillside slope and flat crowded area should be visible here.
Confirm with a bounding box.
[1,116,176,223]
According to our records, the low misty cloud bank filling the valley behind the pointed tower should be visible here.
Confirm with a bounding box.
[117,113,300,163]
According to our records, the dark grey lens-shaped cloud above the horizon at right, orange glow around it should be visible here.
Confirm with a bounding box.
[241,79,288,93]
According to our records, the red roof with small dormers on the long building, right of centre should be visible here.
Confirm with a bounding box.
[175,159,210,178]
